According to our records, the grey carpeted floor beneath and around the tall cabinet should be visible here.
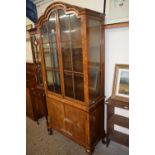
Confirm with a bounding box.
[26,117,129,155]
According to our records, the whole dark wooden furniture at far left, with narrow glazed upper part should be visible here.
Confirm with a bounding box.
[26,29,47,122]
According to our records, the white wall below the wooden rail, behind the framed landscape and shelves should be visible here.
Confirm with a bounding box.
[105,27,129,134]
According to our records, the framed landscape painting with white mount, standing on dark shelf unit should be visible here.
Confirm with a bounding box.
[112,64,129,102]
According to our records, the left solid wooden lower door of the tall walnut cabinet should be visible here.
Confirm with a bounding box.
[47,98,64,131]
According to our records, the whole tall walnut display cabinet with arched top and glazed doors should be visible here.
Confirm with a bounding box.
[36,2,105,154]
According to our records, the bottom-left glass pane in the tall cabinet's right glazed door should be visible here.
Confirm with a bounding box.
[64,73,74,98]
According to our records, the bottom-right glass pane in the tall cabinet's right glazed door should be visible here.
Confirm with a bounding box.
[74,74,84,101]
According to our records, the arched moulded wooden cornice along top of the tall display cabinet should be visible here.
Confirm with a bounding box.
[36,2,104,27]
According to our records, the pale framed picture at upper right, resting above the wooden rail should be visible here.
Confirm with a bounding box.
[105,0,129,24]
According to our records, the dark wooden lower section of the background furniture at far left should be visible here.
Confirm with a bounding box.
[26,63,47,122]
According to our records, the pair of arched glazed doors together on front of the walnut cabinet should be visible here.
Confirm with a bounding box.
[41,9,84,102]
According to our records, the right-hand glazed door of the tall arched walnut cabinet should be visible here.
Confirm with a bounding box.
[58,10,84,101]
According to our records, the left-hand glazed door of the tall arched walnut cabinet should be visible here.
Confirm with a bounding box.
[41,11,61,94]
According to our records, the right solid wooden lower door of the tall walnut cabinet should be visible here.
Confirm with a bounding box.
[65,105,87,144]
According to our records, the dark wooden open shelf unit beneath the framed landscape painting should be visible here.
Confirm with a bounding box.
[106,98,129,146]
